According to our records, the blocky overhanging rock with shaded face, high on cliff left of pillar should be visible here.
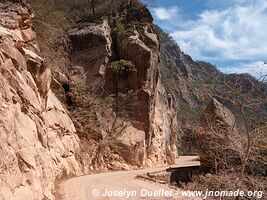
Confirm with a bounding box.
[68,19,112,90]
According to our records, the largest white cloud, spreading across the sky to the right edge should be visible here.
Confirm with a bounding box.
[171,0,267,61]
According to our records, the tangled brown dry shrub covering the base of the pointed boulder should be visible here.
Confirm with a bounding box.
[197,128,244,173]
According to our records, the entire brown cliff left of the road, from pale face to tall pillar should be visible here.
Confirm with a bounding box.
[0,1,180,200]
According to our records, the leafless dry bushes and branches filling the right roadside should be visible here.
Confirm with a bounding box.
[188,72,267,199]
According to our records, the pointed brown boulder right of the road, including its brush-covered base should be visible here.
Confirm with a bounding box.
[199,98,243,172]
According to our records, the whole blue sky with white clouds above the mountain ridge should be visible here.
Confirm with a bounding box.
[150,0,267,78]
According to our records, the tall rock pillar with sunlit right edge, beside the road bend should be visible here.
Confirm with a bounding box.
[117,21,177,166]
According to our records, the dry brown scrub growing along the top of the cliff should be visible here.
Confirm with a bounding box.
[30,0,152,28]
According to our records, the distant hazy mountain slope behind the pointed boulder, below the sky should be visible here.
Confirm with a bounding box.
[156,26,267,127]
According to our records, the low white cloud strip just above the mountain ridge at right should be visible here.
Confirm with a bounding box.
[220,61,267,78]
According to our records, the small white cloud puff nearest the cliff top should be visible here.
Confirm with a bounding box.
[152,6,178,20]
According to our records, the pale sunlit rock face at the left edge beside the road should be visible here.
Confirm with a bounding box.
[0,2,80,200]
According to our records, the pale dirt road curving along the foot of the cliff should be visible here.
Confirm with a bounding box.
[61,156,199,200]
